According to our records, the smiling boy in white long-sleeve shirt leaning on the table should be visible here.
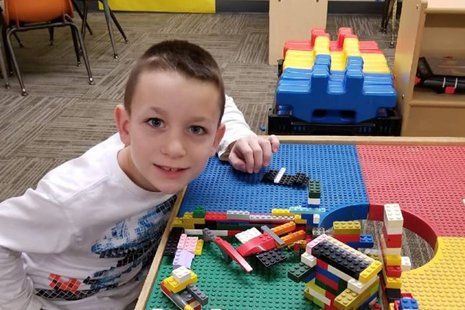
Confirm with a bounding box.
[0,41,279,309]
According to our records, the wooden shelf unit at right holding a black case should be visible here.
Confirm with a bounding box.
[394,0,465,137]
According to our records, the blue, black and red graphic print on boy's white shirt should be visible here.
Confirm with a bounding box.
[36,196,176,300]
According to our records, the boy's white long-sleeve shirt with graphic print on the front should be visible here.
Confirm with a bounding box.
[0,97,253,310]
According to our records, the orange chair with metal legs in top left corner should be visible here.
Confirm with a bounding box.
[3,0,93,95]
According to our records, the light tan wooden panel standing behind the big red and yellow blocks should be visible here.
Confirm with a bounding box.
[268,0,328,65]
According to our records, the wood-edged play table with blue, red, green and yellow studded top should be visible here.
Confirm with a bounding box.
[136,136,465,309]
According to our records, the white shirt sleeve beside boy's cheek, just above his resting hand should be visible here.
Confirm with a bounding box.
[218,96,255,158]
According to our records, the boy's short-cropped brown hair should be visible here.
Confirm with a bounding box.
[124,40,225,119]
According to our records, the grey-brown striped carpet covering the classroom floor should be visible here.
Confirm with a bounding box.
[0,12,433,266]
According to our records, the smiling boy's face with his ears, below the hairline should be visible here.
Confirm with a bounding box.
[115,71,225,193]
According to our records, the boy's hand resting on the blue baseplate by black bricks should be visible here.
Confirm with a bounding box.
[228,135,279,173]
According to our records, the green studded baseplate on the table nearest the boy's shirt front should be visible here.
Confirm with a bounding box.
[146,238,320,310]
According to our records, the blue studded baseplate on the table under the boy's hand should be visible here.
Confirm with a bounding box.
[179,144,368,228]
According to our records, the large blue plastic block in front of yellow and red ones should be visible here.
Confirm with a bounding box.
[276,55,397,124]
